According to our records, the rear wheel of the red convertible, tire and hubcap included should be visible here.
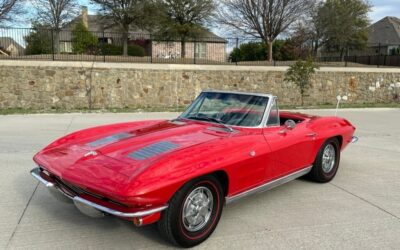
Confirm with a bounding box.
[308,138,340,183]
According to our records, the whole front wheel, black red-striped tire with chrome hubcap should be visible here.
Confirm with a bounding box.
[158,175,224,247]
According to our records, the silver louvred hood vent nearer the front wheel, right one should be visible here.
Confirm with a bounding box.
[128,141,179,161]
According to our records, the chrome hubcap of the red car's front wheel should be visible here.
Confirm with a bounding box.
[182,187,213,232]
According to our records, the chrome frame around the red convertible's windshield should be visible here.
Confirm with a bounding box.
[177,90,279,129]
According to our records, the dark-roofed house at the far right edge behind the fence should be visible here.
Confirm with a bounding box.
[368,16,400,55]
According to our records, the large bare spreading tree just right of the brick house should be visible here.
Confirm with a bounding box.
[217,0,315,61]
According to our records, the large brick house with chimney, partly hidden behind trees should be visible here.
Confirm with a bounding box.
[60,7,227,61]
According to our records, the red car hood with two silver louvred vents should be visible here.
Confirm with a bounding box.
[35,121,222,180]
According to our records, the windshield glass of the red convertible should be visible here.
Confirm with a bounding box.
[180,92,268,127]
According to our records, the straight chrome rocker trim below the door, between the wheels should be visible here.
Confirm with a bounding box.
[225,165,313,205]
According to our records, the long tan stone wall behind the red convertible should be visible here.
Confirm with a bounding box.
[0,61,400,109]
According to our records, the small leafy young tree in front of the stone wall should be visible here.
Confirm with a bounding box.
[285,58,318,106]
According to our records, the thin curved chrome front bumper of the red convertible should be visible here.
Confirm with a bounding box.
[31,168,168,218]
